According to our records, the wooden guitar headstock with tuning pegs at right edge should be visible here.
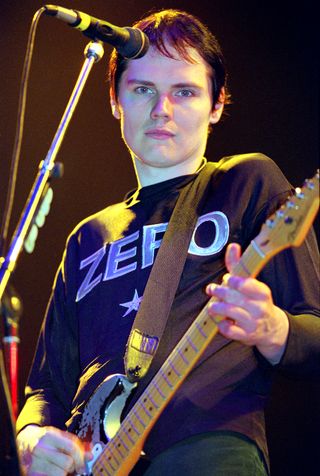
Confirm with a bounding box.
[254,170,319,257]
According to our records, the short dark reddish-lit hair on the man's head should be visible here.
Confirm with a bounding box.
[109,9,230,107]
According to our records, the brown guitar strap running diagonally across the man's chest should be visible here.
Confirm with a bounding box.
[124,159,218,382]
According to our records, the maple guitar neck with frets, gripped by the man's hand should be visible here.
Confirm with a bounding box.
[94,244,264,474]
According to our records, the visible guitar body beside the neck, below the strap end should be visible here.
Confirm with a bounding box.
[76,374,137,475]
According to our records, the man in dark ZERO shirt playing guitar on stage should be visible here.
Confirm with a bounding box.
[18,10,320,476]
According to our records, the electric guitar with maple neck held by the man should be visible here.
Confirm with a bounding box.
[77,172,319,476]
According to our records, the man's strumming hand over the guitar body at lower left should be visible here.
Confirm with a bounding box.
[17,425,91,476]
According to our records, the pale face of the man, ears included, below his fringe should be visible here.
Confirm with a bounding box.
[113,47,222,173]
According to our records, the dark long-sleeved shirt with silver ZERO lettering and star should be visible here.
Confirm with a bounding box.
[18,154,320,464]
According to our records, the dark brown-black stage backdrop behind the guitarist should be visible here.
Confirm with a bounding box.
[0,0,320,476]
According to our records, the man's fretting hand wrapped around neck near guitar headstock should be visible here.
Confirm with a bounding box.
[206,243,289,365]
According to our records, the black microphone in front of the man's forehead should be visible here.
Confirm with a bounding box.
[44,5,149,59]
